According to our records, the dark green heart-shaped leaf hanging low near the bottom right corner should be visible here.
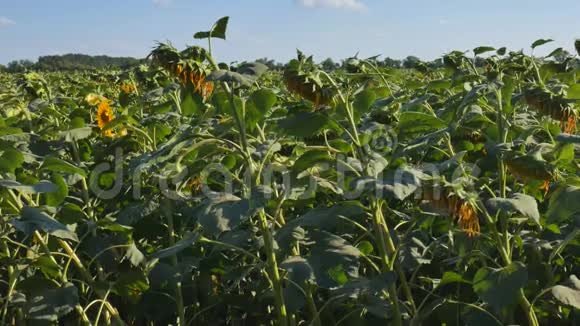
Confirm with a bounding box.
[473,262,528,311]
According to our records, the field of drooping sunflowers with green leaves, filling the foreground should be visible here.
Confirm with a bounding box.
[0,17,580,326]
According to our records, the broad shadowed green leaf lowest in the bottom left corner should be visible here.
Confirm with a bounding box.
[24,283,79,322]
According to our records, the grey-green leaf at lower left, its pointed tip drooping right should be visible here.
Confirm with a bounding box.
[10,206,79,241]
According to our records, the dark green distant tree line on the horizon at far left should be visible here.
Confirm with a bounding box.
[0,54,142,72]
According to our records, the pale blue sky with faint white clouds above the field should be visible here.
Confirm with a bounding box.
[0,0,580,64]
